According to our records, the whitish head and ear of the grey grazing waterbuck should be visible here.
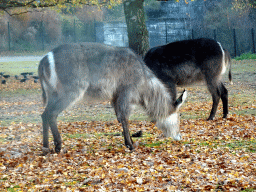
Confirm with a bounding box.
[156,90,187,141]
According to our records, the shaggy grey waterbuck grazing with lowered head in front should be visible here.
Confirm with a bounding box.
[38,43,187,153]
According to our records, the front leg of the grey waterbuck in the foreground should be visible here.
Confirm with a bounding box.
[112,87,134,150]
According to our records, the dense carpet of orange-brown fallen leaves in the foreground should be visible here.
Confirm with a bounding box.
[0,115,256,191]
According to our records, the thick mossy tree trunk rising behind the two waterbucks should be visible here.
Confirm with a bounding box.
[124,0,149,57]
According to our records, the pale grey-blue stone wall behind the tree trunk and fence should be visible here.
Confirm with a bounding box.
[96,0,203,47]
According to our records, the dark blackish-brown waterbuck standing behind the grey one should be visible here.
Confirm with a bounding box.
[144,38,232,120]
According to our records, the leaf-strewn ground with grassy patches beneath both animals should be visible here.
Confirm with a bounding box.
[0,59,256,192]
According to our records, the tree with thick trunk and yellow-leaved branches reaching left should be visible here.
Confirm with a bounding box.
[0,0,149,56]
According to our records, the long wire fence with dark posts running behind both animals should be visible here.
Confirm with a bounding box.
[0,19,256,57]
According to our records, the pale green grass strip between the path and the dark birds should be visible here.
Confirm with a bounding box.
[0,61,39,76]
